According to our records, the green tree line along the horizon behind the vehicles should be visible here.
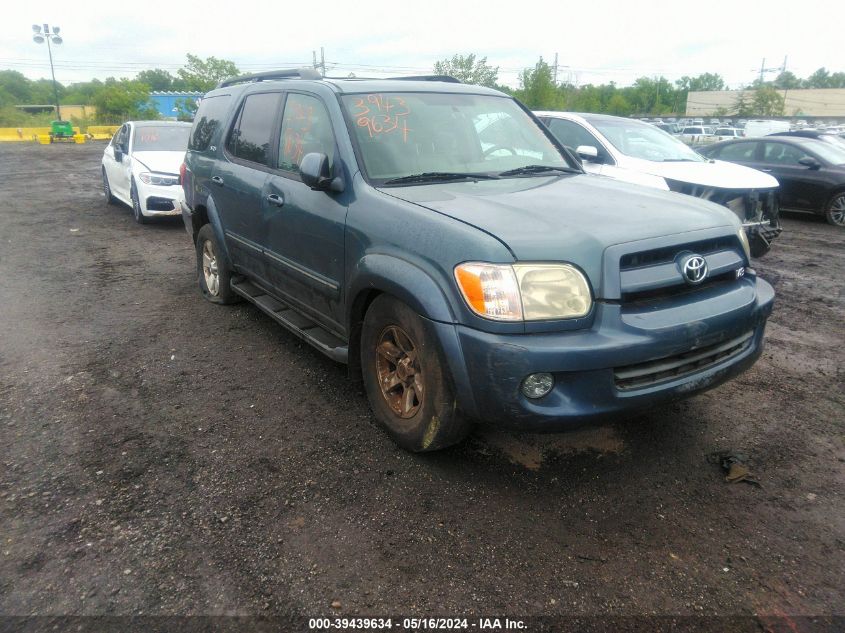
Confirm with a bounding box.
[0,54,845,126]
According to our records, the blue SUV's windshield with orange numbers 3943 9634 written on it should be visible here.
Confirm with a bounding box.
[342,92,574,184]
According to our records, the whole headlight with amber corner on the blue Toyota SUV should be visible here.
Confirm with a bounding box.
[455,262,593,321]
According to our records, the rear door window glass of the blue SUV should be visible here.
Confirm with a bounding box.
[227,92,282,166]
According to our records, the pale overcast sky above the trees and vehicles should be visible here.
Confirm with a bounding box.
[0,0,845,88]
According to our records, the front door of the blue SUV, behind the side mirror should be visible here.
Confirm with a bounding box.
[261,91,347,334]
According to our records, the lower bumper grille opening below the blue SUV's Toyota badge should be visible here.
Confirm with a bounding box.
[613,331,754,391]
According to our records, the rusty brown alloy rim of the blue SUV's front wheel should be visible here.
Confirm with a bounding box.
[375,325,425,419]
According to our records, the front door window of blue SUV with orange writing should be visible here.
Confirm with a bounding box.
[278,93,335,173]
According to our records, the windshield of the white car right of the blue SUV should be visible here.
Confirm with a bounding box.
[585,117,706,162]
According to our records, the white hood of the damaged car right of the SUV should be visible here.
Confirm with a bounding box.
[626,159,778,189]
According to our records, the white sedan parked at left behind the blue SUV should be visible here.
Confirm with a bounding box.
[102,121,191,224]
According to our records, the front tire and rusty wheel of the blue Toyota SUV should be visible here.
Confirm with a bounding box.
[361,295,472,452]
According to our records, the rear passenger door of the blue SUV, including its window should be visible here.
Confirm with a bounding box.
[209,91,283,283]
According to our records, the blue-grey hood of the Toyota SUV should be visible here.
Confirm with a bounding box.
[381,174,739,276]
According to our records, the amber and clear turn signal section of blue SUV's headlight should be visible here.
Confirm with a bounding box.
[455,262,522,321]
